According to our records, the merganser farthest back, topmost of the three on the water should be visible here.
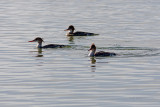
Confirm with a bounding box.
[64,25,98,36]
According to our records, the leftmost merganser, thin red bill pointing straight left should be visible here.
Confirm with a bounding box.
[28,37,65,48]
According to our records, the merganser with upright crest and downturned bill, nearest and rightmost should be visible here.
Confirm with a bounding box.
[88,43,116,57]
